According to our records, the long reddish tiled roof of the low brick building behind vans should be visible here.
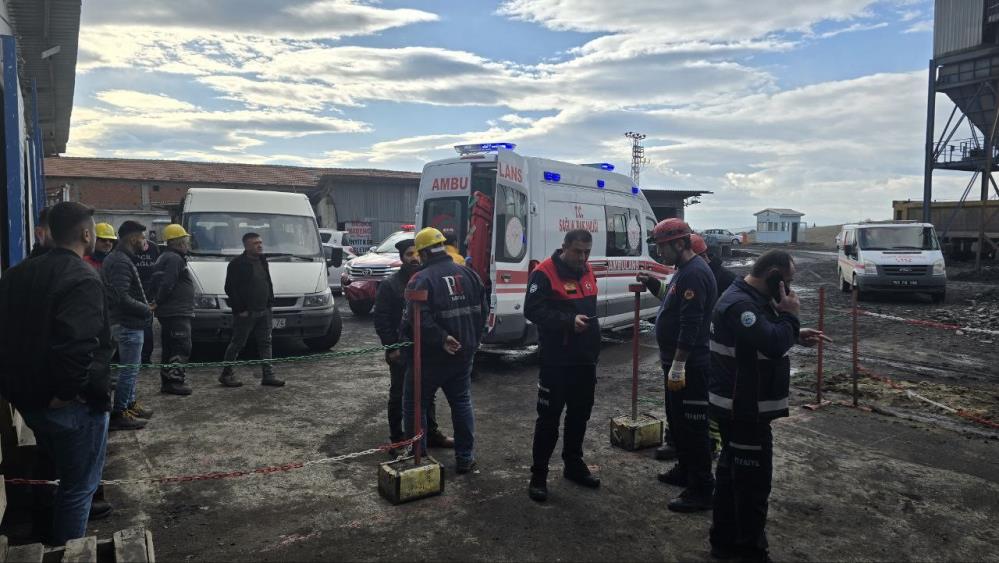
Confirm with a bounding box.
[45,157,420,188]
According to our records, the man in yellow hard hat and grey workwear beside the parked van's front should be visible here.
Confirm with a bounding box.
[152,224,194,395]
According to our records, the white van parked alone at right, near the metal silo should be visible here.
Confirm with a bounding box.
[836,221,947,303]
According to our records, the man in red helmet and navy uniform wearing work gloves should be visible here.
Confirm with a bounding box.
[638,218,718,512]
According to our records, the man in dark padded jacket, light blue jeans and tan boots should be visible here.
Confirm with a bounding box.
[101,221,153,430]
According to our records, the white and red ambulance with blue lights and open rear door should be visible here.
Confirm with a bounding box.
[416,143,672,347]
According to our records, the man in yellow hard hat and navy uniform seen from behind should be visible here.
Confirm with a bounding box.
[400,227,489,474]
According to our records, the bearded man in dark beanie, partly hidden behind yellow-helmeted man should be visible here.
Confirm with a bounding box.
[374,239,454,454]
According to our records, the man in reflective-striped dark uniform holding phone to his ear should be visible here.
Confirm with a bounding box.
[708,250,831,561]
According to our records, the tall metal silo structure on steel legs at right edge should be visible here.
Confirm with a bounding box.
[923,0,999,266]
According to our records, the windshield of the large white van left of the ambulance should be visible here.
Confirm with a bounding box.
[184,212,322,258]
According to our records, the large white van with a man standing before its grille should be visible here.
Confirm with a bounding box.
[181,188,342,351]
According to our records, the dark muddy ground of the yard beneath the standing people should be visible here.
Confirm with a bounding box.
[62,253,999,561]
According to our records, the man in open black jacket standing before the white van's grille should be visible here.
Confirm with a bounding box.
[219,233,284,387]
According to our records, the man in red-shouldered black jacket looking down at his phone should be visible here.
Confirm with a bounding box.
[524,230,600,502]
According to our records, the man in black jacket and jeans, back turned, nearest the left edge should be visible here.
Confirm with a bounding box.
[0,202,112,545]
